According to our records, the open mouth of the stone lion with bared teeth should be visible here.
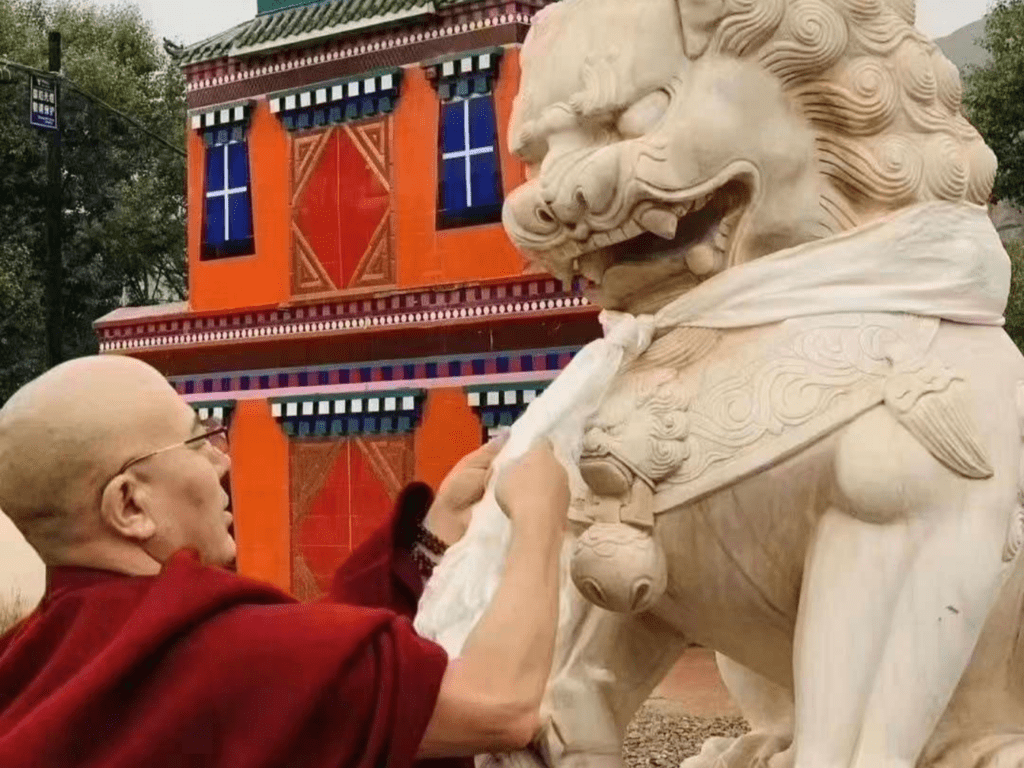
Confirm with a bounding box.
[552,169,755,291]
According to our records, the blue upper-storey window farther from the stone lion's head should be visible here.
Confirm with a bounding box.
[203,138,255,259]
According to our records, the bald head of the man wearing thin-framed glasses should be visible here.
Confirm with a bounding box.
[0,356,234,575]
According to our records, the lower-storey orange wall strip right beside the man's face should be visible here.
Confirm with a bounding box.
[230,400,292,591]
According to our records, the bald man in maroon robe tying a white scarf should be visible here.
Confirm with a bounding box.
[0,357,568,768]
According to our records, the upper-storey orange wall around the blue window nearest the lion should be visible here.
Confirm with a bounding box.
[393,49,525,288]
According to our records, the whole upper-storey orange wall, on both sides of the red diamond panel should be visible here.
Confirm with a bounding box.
[188,48,525,312]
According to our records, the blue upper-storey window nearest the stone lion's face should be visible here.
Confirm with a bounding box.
[437,93,502,228]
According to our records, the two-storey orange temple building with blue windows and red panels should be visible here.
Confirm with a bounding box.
[96,0,599,598]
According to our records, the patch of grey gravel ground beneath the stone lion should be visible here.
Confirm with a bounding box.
[623,700,748,768]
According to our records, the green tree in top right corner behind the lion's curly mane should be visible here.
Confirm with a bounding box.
[964,0,1024,205]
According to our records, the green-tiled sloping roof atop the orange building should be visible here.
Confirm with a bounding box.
[176,0,474,66]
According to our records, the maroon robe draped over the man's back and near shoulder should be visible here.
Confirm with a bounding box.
[0,524,447,768]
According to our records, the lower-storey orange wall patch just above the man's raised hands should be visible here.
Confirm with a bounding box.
[416,388,482,490]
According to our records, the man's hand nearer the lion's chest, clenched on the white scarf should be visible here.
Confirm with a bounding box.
[496,440,569,530]
